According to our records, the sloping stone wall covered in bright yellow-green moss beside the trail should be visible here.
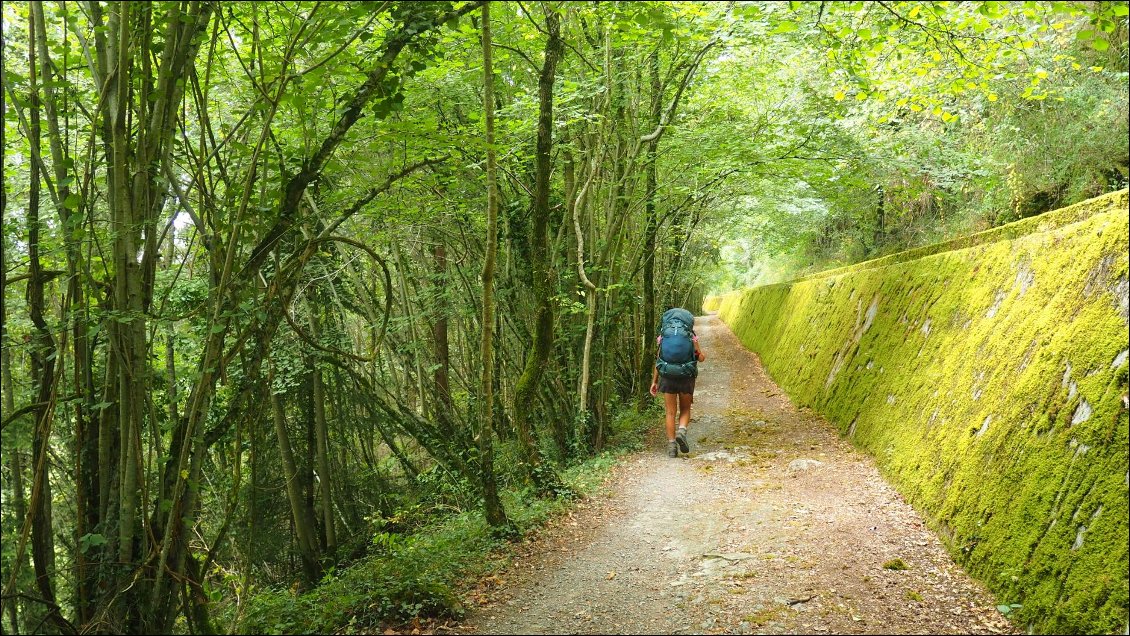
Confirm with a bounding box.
[705,190,1130,634]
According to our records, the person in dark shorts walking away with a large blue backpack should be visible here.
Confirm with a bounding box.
[651,307,706,458]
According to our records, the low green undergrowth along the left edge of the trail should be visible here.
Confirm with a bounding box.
[231,408,662,634]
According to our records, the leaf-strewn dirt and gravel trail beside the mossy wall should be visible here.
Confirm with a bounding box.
[459,316,1015,634]
